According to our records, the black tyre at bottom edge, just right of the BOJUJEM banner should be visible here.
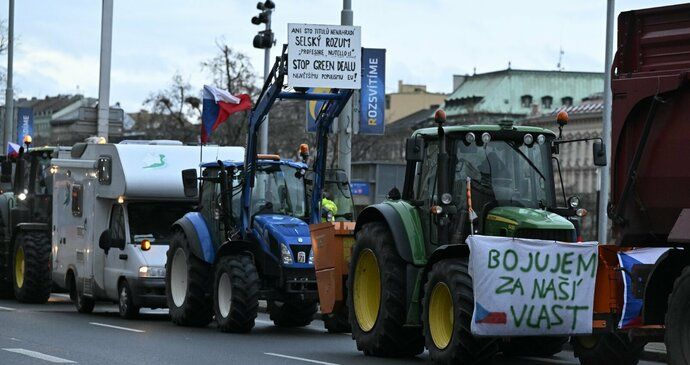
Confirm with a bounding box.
[571,333,645,365]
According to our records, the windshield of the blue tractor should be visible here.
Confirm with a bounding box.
[251,164,307,218]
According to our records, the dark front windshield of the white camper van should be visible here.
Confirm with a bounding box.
[127,202,193,245]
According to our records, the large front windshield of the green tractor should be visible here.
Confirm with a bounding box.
[455,140,555,211]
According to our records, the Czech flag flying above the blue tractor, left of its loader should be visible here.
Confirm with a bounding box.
[201,85,252,143]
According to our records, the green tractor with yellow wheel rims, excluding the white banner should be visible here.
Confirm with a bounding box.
[347,110,605,364]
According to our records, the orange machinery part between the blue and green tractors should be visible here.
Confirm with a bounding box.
[309,222,355,314]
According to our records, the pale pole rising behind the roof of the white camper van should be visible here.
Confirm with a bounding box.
[97,0,113,141]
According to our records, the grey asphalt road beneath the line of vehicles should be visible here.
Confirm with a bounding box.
[0,294,658,365]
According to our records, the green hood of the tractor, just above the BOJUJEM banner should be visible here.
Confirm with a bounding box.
[486,207,575,230]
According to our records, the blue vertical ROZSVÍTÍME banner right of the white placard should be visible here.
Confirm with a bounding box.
[359,48,386,134]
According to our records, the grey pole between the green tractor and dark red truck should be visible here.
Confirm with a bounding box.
[597,0,615,244]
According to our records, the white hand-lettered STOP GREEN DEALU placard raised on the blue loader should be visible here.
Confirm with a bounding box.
[288,23,362,89]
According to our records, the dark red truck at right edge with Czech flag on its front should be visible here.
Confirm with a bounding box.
[572,4,690,365]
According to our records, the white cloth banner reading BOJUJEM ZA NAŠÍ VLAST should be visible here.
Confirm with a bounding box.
[467,235,598,336]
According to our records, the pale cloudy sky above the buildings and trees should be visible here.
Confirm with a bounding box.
[5,0,682,112]
